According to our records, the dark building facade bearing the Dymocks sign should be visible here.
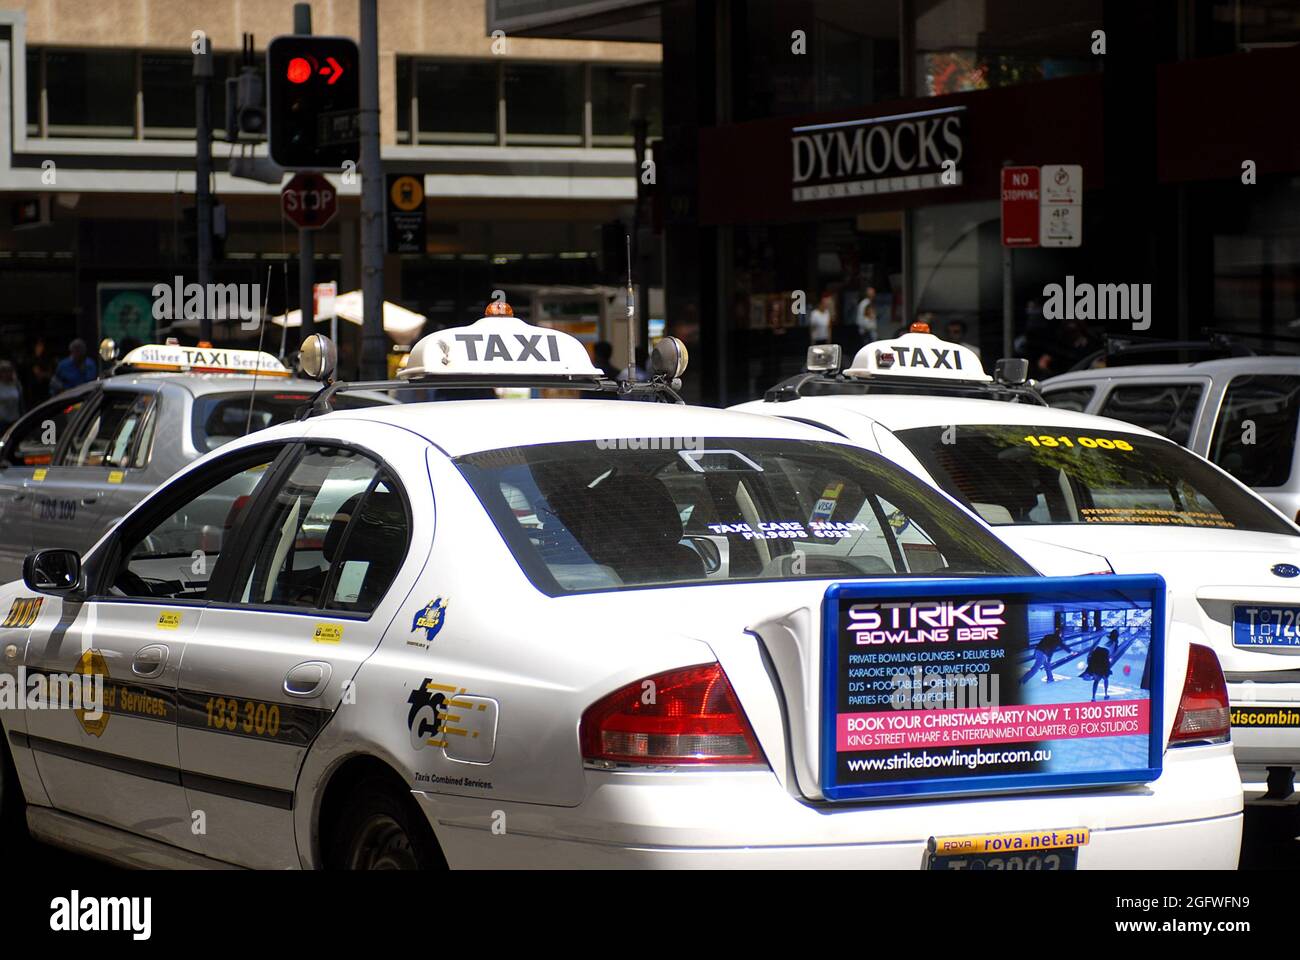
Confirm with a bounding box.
[501,0,1300,402]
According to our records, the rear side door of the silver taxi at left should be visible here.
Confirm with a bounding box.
[31,389,155,553]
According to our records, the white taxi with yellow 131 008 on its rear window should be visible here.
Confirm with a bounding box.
[735,330,1300,801]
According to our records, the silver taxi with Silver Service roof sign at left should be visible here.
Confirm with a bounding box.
[0,342,391,581]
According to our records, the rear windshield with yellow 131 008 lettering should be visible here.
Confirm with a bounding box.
[898,424,1295,533]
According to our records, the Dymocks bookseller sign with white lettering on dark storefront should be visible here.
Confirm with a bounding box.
[790,107,966,202]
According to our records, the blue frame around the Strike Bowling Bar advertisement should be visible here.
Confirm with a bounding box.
[818,574,1166,800]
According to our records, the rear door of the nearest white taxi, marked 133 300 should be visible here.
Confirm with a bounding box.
[178,423,433,868]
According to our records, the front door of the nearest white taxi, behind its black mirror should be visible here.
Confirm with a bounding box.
[26,444,285,852]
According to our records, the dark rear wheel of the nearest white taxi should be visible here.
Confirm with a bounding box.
[333,777,447,870]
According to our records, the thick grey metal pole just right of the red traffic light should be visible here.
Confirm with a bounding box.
[360,0,387,380]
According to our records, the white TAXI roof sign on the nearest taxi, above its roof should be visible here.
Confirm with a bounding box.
[398,315,603,380]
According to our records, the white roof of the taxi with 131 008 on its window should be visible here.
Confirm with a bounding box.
[738,394,1158,437]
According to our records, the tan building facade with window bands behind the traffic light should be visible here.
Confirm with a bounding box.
[0,0,659,382]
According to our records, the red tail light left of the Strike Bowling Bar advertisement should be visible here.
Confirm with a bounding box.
[579,663,764,765]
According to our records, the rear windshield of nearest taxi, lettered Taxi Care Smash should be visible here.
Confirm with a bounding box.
[456,437,1034,596]
